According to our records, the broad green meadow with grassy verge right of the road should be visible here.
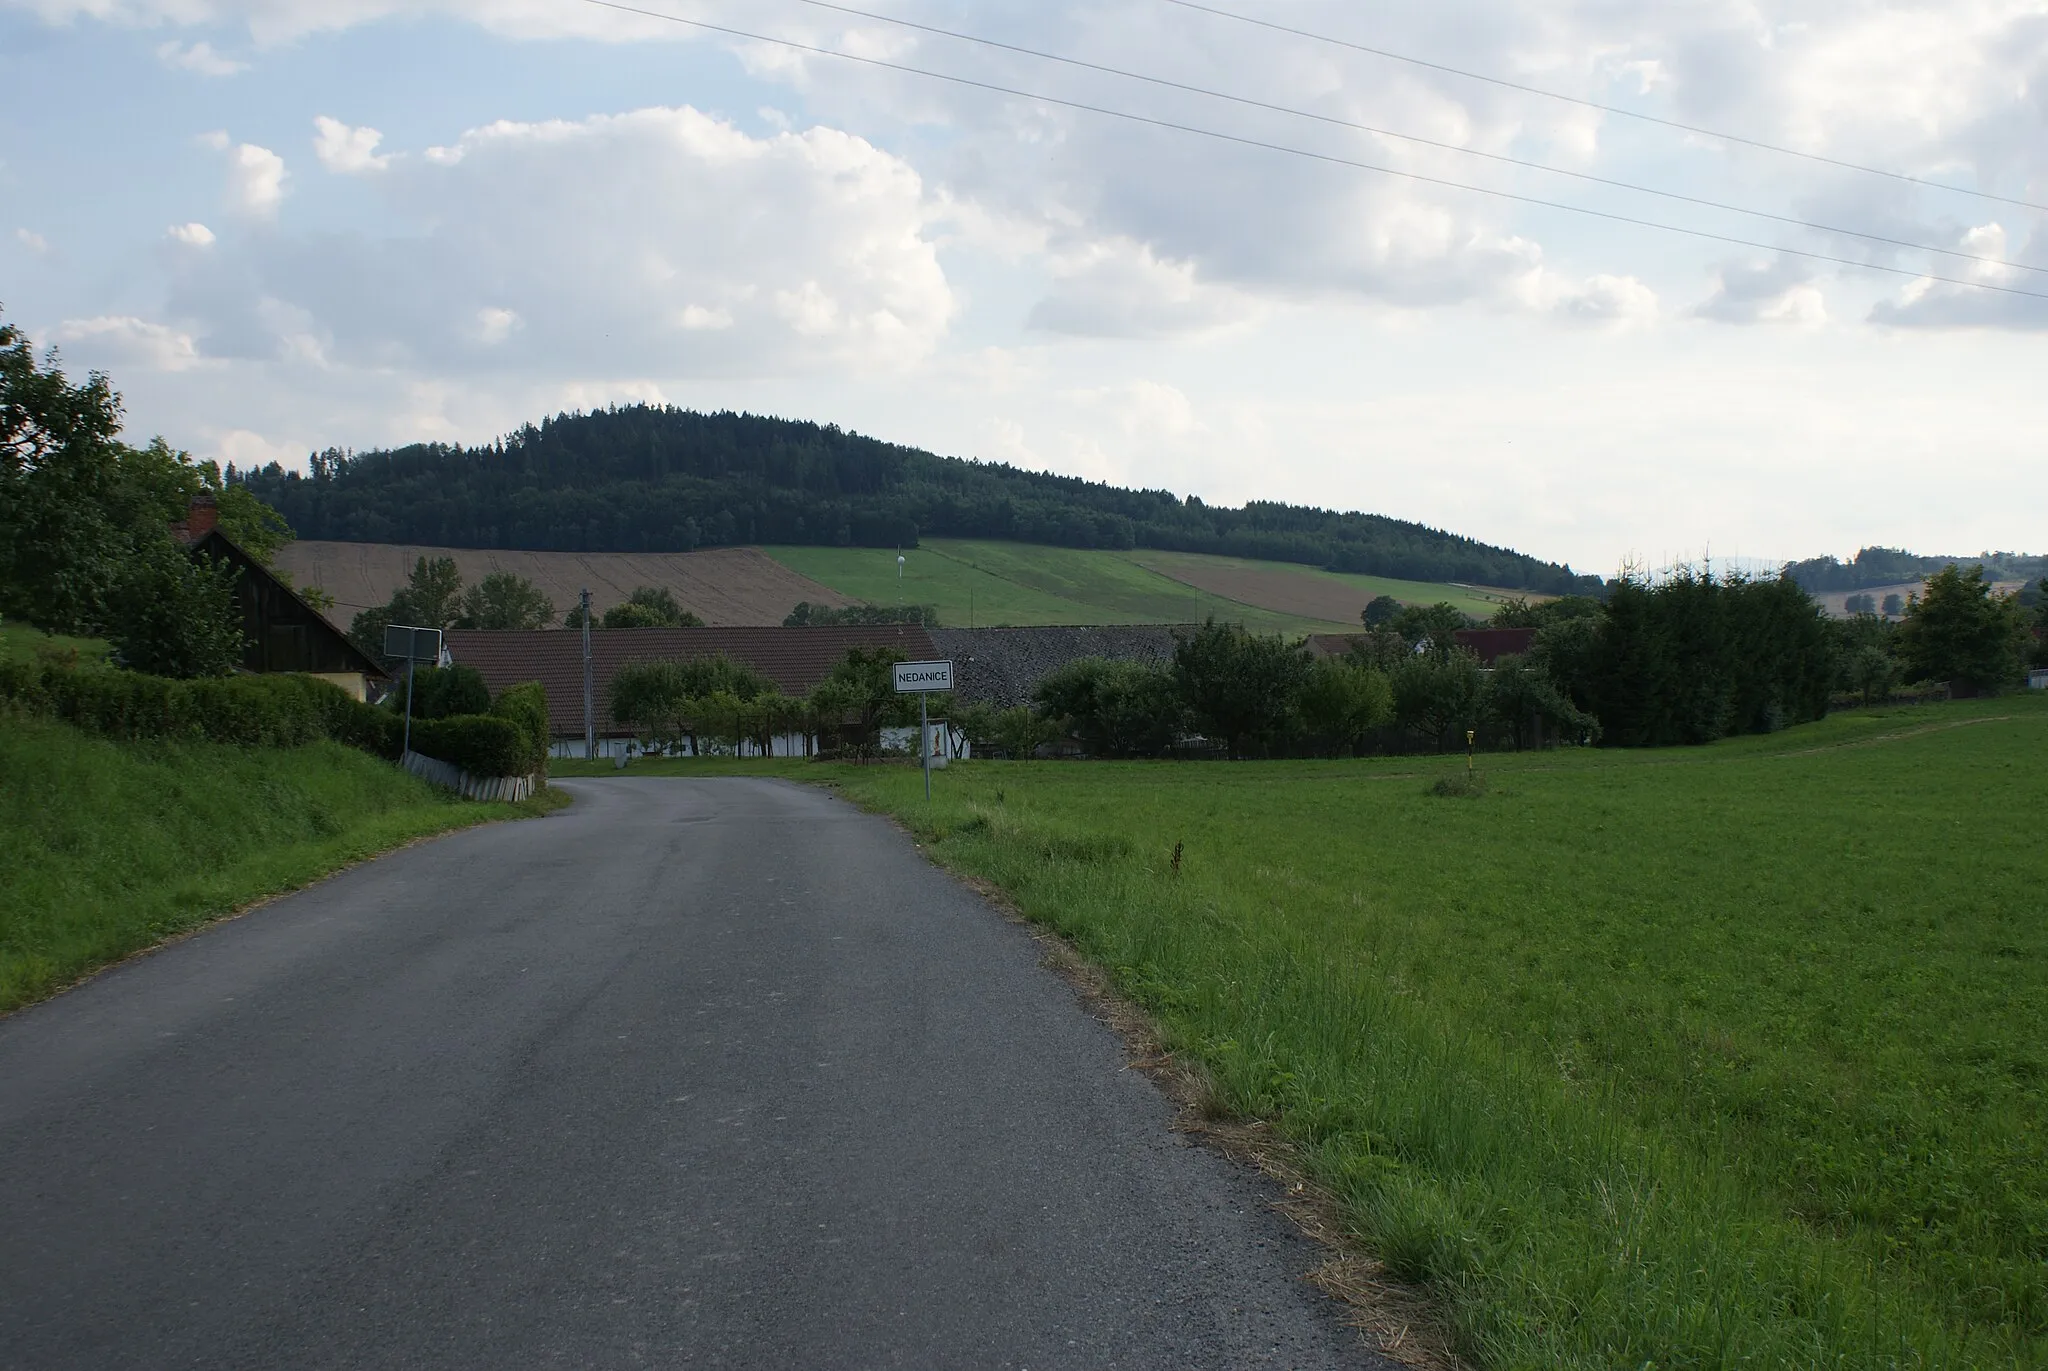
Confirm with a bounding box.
[819,697,2048,1369]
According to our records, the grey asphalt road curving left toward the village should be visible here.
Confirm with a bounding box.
[0,779,1380,1371]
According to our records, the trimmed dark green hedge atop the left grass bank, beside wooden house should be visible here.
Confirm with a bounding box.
[0,662,549,777]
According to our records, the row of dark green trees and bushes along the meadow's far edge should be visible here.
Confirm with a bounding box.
[952,566,2048,758]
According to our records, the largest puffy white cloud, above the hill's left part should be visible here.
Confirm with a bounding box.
[174,109,954,377]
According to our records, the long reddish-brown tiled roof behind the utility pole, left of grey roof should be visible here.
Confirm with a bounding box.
[446,627,938,738]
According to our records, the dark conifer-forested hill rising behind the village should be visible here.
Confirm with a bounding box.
[238,406,1599,592]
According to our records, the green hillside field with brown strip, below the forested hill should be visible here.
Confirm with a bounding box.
[764,539,1491,633]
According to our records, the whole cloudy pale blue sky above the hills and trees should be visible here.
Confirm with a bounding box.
[0,0,2048,574]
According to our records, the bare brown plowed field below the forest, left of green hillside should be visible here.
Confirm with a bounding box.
[279,541,854,627]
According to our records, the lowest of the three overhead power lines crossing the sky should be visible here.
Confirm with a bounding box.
[584,0,2048,299]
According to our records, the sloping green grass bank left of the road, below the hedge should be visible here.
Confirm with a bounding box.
[0,715,567,1012]
